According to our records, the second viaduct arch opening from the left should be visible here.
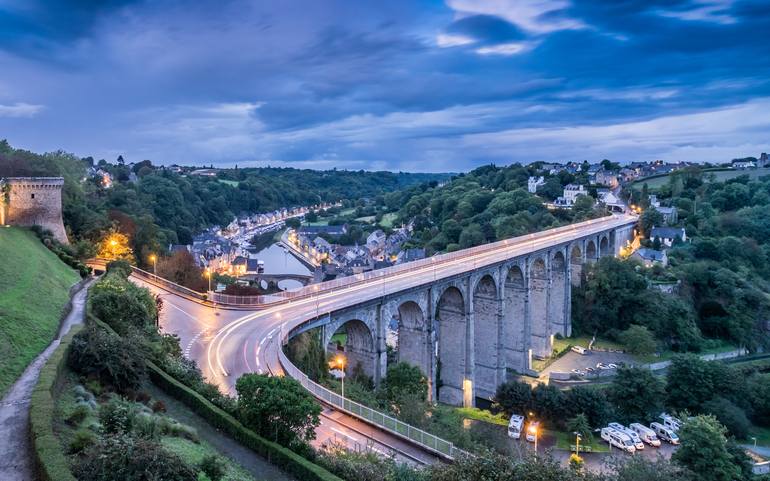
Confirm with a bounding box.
[395,301,430,376]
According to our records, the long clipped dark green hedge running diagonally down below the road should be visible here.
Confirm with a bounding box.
[87,306,342,481]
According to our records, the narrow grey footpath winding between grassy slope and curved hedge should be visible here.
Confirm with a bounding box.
[0,282,91,481]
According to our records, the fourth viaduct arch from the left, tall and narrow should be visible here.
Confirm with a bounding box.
[473,274,499,399]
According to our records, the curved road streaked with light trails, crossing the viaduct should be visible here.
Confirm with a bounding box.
[137,215,637,463]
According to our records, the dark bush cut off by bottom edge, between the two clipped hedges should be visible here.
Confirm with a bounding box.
[75,436,197,481]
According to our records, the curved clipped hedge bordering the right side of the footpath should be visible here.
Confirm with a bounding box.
[29,324,83,481]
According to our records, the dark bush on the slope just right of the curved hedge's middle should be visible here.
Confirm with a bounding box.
[67,327,145,392]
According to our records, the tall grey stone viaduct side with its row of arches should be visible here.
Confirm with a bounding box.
[295,220,634,406]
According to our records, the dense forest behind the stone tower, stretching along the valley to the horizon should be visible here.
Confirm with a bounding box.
[0,141,448,260]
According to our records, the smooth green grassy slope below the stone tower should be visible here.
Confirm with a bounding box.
[0,227,79,396]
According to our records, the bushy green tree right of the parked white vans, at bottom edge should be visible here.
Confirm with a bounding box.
[672,415,742,481]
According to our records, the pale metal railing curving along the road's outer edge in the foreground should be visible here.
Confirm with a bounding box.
[278,348,462,459]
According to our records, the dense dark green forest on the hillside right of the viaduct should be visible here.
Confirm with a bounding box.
[573,168,770,351]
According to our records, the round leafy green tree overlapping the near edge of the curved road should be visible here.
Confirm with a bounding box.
[235,374,321,446]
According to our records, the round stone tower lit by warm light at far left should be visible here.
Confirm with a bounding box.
[0,177,69,244]
